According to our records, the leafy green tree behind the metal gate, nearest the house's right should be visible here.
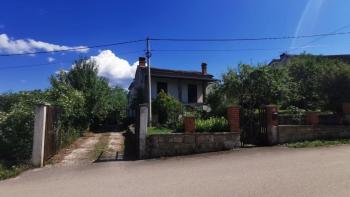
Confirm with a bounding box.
[222,64,288,107]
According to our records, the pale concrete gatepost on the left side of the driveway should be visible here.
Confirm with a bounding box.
[32,105,47,167]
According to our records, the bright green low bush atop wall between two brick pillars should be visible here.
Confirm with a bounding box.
[196,117,230,132]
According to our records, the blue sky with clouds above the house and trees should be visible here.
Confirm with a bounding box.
[0,0,350,92]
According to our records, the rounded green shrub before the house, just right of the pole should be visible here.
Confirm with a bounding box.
[153,91,183,128]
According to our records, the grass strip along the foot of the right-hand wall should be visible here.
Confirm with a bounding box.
[286,139,350,148]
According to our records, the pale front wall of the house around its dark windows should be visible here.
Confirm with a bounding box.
[151,77,203,103]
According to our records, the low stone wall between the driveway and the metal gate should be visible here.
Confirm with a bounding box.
[146,132,240,158]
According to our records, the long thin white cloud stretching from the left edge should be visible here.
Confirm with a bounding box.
[0,34,89,54]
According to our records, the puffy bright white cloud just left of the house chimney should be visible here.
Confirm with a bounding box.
[90,50,138,88]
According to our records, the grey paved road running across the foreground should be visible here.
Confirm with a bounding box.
[0,145,350,197]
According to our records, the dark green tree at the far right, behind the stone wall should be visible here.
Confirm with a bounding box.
[279,54,350,111]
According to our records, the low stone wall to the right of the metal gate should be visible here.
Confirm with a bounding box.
[275,125,350,144]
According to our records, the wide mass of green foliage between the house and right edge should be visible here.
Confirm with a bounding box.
[208,54,350,112]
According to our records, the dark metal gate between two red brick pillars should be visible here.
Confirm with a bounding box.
[240,106,267,146]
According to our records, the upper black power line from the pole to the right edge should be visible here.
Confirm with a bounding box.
[150,31,350,42]
